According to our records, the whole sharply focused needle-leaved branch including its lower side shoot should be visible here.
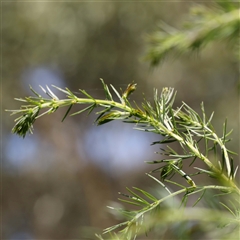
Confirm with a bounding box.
[8,79,240,239]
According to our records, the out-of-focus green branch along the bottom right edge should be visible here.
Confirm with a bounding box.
[97,202,239,240]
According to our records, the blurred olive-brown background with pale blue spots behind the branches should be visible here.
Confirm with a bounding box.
[1,1,239,240]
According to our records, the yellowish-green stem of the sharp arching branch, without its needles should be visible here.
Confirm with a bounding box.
[9,92,240,195]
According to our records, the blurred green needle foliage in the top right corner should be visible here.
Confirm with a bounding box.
[146,1,240,65]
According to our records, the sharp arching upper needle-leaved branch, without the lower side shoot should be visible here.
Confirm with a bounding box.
[6,79,240,193]
